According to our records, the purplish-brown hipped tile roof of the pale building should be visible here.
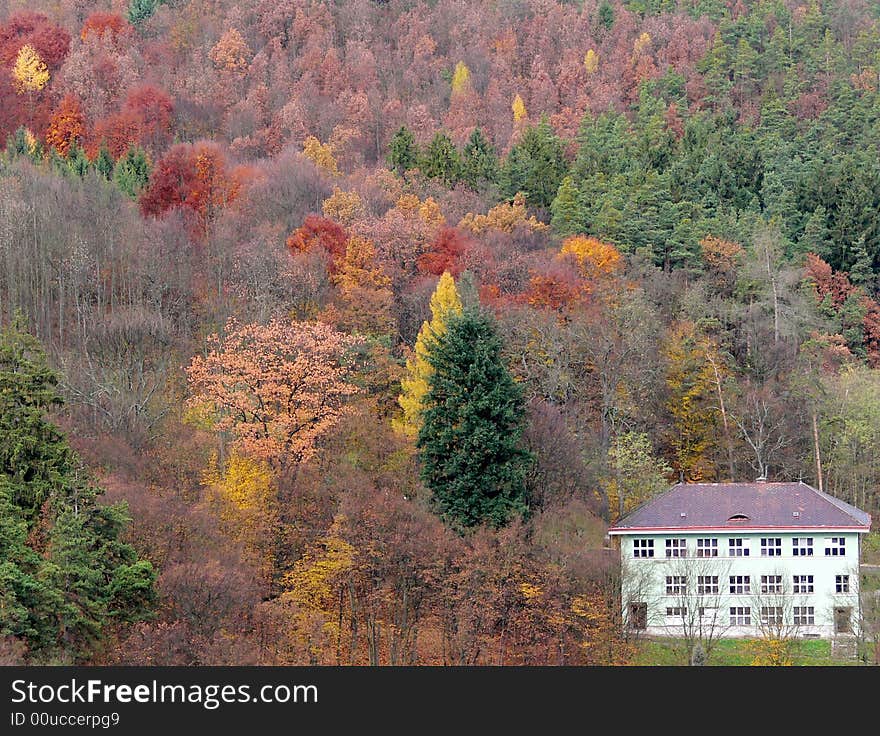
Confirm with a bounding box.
[610,482,871,531]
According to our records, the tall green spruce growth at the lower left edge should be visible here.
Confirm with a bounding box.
[0,318,156,662]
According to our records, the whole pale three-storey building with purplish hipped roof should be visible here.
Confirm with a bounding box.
[608,481,871,640]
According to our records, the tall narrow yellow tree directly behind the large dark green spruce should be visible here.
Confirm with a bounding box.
[393,271,462,437]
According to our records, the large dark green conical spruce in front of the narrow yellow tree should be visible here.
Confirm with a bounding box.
[418,307,531,529]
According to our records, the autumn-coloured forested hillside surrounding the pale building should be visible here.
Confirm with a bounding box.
[0,0,880,665]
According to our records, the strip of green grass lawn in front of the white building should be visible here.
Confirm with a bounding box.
[632,638,861,667]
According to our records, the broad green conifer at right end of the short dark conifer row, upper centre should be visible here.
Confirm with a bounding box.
[501,118,568,207]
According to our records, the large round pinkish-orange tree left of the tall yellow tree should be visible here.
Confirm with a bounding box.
[187,320,357,470]
